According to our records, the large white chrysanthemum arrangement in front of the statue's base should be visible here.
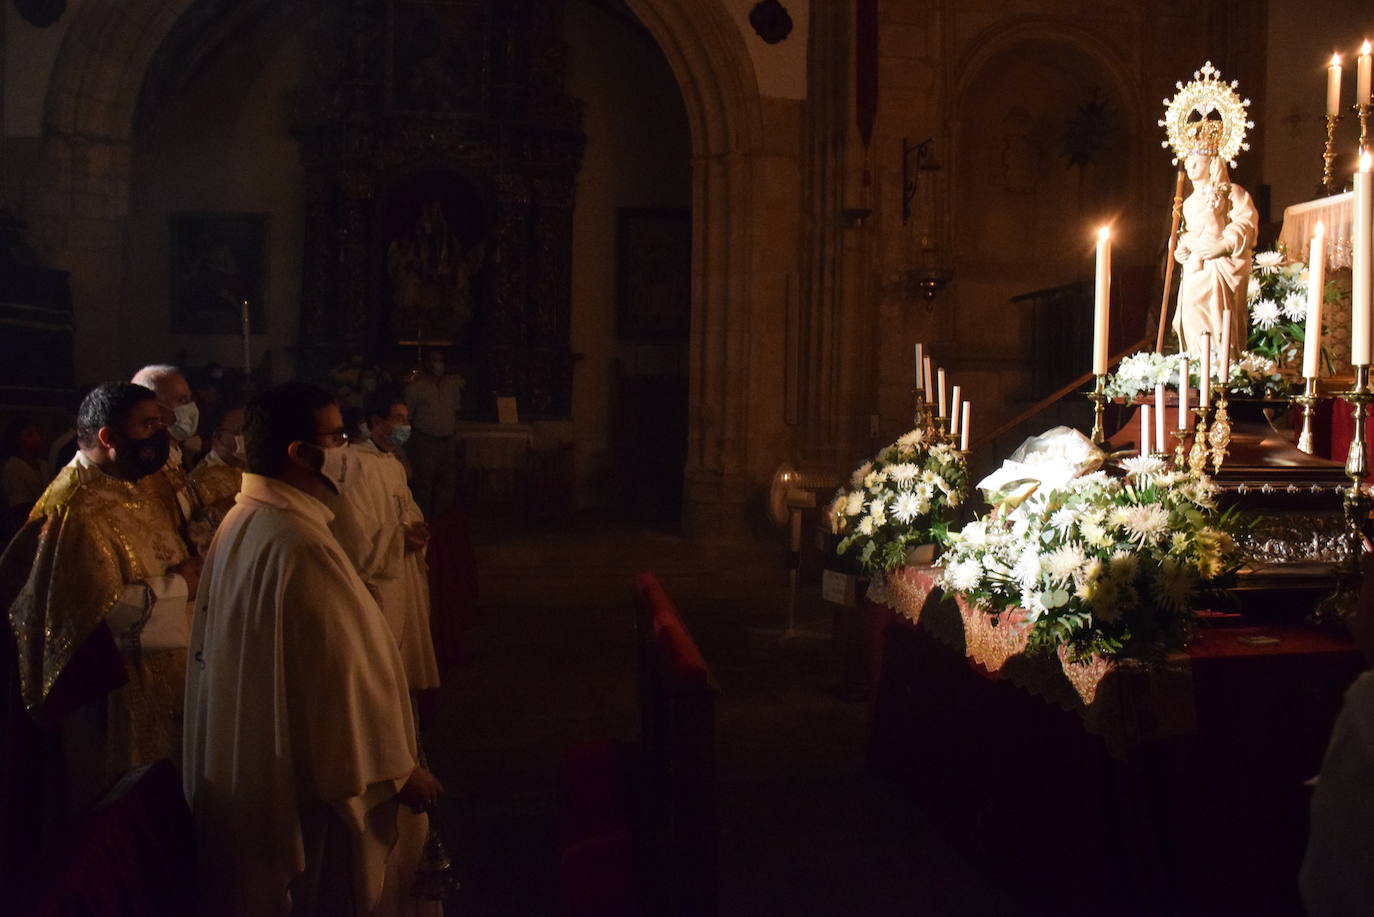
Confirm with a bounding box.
[940,456,1241,660]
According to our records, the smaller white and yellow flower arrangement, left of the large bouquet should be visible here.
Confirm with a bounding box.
[829,430,969,572]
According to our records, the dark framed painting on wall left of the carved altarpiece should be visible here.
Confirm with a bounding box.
[168,212,269,334]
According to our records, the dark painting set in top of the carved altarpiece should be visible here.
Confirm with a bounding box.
[386,0,486,115]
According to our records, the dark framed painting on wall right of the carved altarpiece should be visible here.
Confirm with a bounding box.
[617,208,691,338]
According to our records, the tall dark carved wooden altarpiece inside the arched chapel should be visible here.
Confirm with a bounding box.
[295,0,585,419]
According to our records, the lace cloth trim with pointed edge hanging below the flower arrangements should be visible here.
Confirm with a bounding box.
[868,565,1197,758]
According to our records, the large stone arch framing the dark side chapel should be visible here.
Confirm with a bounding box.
[27,0,763,528]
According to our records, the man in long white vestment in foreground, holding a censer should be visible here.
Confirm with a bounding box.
[185,382,441,917]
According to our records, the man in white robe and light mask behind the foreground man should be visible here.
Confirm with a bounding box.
[331,392,438,693]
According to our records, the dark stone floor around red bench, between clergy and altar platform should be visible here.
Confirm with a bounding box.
[427,524,1022,917]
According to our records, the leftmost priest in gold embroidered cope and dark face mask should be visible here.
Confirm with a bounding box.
[0,382,199,846]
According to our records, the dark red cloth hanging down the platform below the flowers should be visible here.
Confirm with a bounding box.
[868,595,1362,916]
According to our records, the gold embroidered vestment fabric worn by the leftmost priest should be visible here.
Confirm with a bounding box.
[0,465,187,775]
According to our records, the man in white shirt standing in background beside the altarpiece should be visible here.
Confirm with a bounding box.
[405,348,463,520]
